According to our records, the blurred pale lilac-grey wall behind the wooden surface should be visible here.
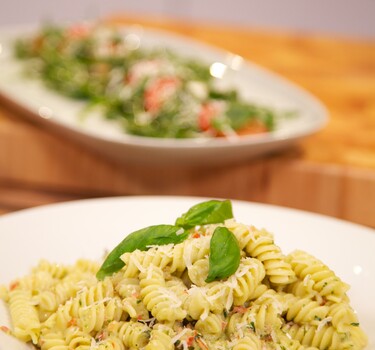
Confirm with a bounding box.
[0,0,375,39]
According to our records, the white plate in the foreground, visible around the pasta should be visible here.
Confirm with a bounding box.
[0,197,375,350]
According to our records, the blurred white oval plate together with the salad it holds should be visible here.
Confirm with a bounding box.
[0,22,326,163]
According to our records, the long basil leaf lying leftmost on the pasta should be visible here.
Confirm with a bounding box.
[96,225,188,280]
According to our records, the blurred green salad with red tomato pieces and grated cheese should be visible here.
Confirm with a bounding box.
[15,24,284,138]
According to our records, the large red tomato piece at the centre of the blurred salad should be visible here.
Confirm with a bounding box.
[144,77,180,113]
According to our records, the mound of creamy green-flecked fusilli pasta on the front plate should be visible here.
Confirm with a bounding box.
[0,201,367,350]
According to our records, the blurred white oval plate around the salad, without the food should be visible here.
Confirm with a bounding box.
[0,27,327,164]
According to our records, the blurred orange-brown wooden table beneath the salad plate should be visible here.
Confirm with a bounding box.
[0,17,375,227]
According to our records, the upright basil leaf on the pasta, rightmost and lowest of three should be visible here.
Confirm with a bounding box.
[206,227,241,282]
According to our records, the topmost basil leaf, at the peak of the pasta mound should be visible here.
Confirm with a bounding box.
[176,199,233,229]
